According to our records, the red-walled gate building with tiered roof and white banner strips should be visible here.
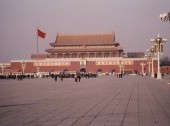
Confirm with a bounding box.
[1,32,157,74]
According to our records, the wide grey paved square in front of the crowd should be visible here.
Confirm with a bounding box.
[0,76,170,126]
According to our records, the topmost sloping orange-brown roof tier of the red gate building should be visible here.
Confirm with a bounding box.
[50,32,116,47]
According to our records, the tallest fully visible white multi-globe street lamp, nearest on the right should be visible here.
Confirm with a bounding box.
[150,35,166,79]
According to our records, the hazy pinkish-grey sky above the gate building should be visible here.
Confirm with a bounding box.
[0,0,170,62]
